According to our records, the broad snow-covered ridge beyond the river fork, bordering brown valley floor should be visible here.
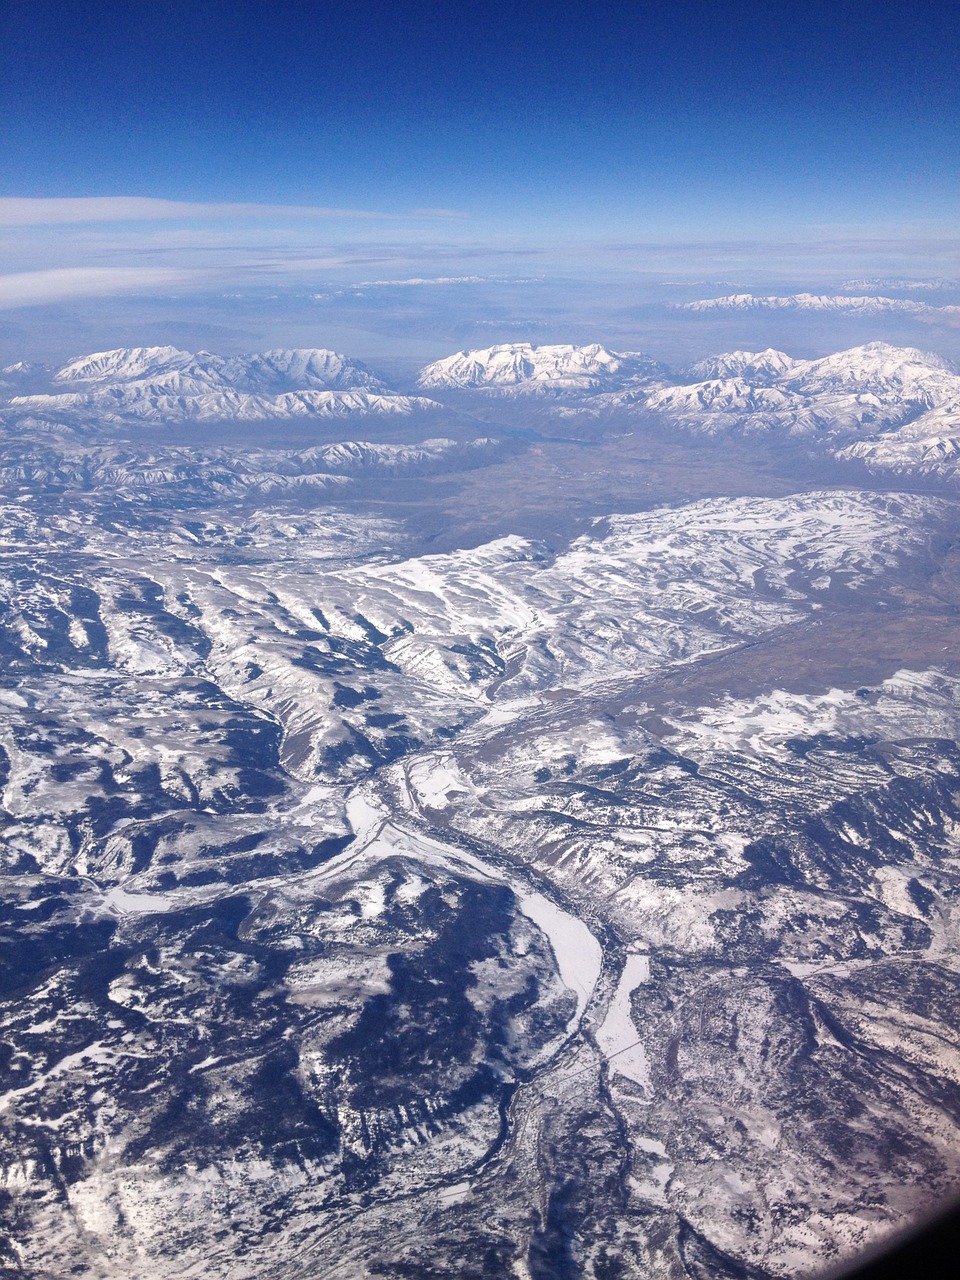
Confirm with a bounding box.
[326,493,929,700]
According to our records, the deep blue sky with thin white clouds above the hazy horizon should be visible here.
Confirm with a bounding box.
[0,0,960,304]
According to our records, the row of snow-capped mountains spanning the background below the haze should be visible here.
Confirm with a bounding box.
[0,337,960,480]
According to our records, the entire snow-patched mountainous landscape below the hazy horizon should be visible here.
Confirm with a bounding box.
[0,322,960,1280]
